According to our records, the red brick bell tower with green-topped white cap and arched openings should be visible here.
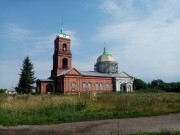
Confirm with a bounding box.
[51,29,72,79]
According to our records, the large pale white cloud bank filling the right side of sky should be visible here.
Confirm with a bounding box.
[96,0,180,81]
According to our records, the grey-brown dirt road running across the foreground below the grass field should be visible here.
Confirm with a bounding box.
[0,113,180,135]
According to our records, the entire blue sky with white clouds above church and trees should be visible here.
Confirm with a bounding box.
[0,0,180,88]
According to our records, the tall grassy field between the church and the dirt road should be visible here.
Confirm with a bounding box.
[0,93,180,126]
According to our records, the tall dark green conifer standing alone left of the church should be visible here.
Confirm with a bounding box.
[15,56,36,94]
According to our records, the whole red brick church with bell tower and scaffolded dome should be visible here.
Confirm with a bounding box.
[36,26,134,94]
